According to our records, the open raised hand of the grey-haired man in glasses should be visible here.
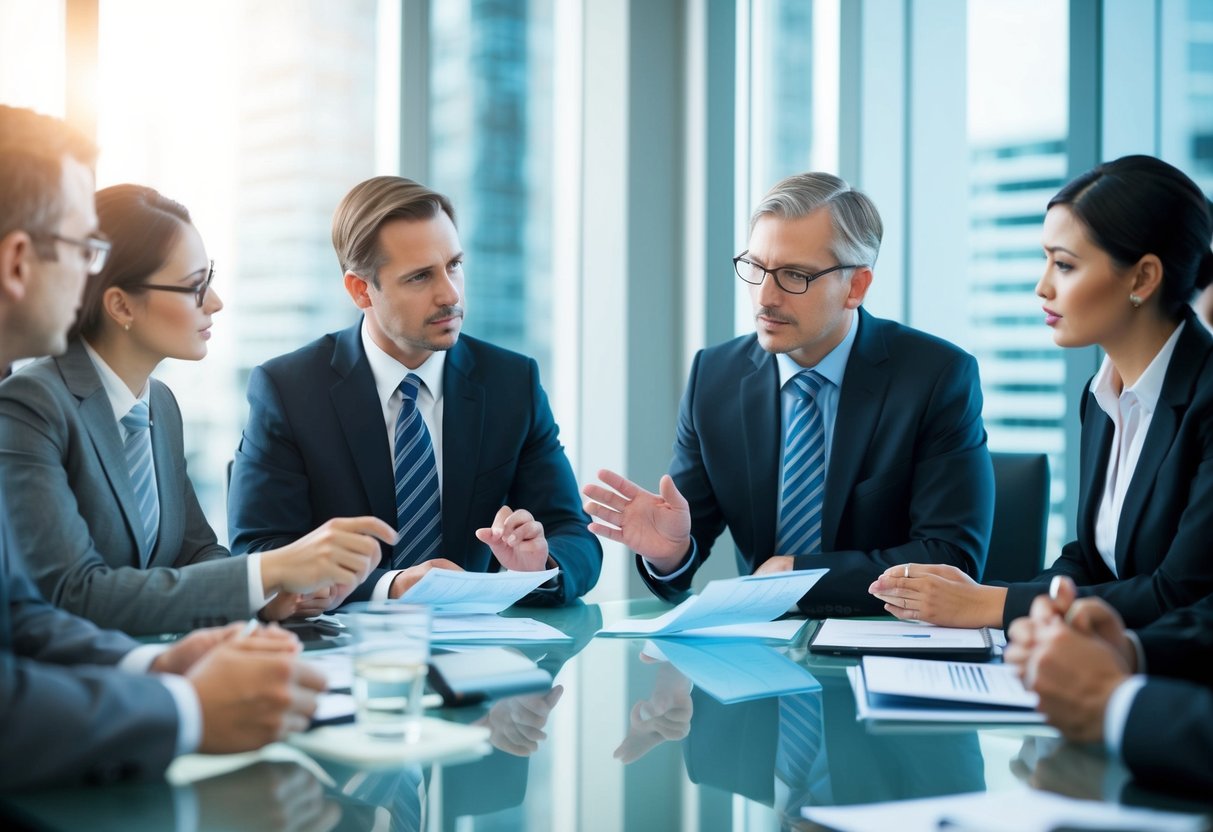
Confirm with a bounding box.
[581,468,690,572]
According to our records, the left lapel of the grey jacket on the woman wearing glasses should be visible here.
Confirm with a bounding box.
[55,341,146,566]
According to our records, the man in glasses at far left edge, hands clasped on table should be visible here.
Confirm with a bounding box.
[0,106,324,790]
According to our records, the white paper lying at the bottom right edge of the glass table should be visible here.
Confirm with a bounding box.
[802,788,1208,832]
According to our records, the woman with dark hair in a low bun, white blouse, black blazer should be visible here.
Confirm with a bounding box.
[871,156,1213,627]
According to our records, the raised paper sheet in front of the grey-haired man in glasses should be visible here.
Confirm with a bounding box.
[598,569,827,638]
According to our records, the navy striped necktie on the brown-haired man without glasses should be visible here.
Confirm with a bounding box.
[392,372,443,569]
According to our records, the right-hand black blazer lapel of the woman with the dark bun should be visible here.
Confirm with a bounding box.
[1105,315,1213,575]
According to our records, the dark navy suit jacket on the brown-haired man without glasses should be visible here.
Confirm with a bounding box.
[228,323,602,603]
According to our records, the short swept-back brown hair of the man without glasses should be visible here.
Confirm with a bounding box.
[332,176,455,287]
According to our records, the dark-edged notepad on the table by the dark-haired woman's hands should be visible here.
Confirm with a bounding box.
[809,619,995,661]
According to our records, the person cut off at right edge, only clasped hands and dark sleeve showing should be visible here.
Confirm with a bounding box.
[1006,576,1213,796]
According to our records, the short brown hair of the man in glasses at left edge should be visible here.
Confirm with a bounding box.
[0,104,97,246]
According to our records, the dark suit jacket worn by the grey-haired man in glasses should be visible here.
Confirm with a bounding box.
[637,309,993,617]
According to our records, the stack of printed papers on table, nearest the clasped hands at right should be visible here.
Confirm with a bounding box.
[847,656,1044,723]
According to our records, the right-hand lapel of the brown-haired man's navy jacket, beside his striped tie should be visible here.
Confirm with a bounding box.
[437,338,482,563]
